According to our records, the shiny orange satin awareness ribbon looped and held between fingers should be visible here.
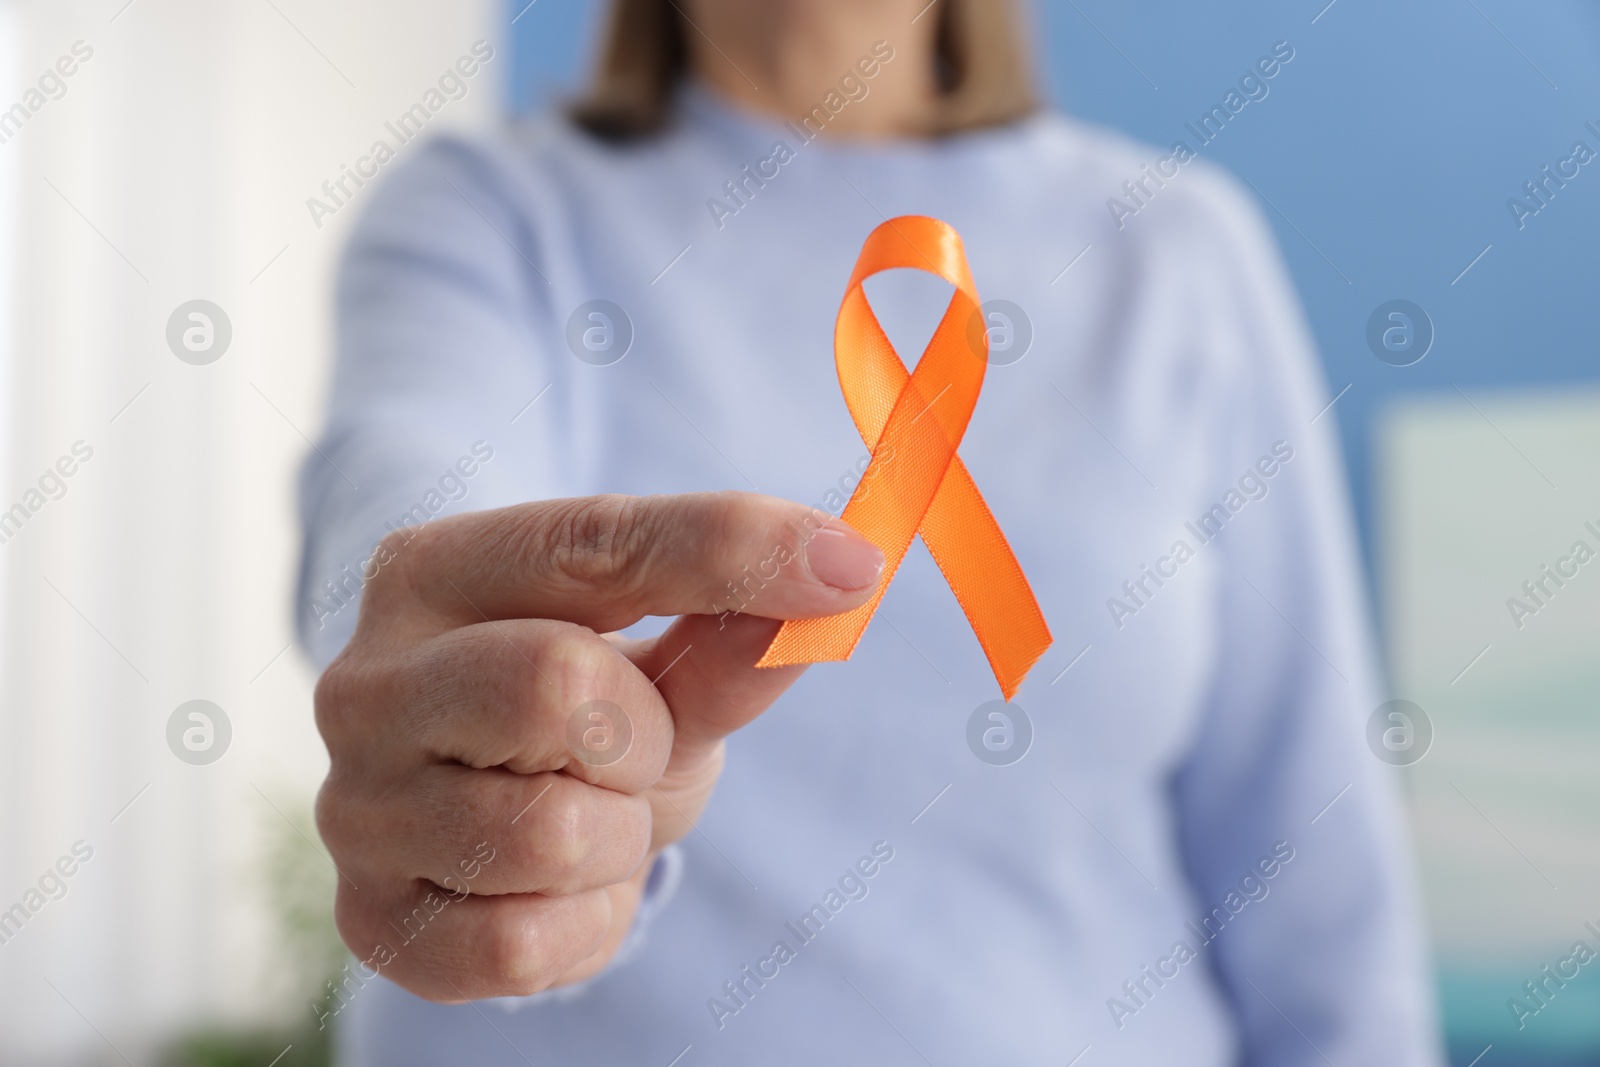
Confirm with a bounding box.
[757,216,1051,701]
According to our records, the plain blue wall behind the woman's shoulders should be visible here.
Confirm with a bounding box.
[507,0,1600,575]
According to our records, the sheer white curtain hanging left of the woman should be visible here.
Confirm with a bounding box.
[0,0,496,1064]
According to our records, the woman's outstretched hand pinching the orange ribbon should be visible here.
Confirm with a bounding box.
[308,493,883,1001]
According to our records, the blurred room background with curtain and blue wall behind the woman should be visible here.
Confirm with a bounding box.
[0,0,1600,1067]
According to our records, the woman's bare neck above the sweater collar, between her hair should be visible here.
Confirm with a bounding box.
[680,0,939,138]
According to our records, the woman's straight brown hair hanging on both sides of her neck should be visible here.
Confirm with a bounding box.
[570,0,1038,141]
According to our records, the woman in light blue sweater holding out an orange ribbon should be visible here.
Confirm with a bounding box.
[302,0,1437,1065]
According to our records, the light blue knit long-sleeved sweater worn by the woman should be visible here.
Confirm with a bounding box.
[301,90,1438,1067]
